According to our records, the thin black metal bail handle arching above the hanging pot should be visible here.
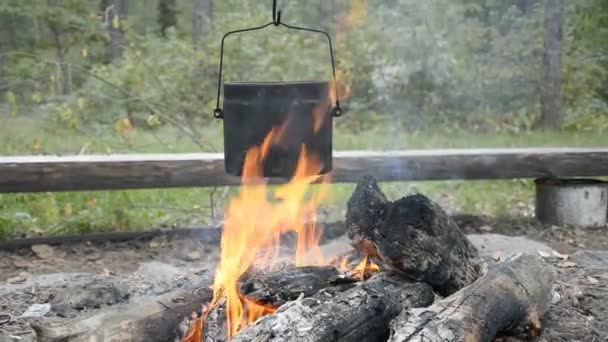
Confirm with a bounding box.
[213,0,343,119]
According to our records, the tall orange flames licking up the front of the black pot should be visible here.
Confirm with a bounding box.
[184,124,328,341]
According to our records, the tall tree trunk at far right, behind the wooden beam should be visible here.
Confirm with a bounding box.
[540,0,564,129]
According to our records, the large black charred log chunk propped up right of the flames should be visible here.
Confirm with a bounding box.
[346,177,479,296]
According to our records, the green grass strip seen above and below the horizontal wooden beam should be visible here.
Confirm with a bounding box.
[0,117,608,239]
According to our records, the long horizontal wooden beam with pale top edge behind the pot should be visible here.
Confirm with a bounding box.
[0,148,608,193]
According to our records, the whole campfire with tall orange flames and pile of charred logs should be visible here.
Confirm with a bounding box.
[182,129,554,342]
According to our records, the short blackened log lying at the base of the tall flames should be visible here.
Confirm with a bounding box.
[240,266,356,307]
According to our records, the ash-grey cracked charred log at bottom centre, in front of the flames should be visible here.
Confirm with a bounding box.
[232,273,434,342]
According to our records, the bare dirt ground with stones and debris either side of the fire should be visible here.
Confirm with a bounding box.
[0,215,608,342]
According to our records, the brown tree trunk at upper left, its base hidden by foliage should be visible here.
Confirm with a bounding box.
[102,0,128,63]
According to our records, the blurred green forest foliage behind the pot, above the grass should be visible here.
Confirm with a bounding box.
[0,0,608,131]
